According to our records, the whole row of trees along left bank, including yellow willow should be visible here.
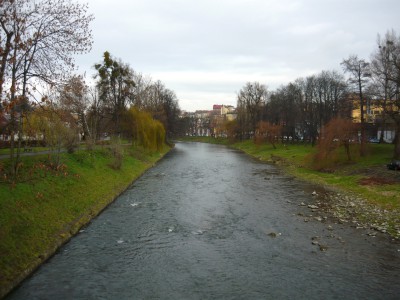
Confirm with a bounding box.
[0,0,180,177]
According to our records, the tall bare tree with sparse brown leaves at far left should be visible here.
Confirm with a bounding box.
[0,0,93,175]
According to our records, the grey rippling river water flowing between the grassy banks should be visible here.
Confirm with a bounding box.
[8,143,400,299]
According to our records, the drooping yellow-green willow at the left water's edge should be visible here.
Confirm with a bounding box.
[128,107,165,151]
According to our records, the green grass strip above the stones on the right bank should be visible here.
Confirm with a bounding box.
[232,141,400,209]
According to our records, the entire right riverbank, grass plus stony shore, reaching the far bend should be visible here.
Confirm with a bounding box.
[180,137,400,240]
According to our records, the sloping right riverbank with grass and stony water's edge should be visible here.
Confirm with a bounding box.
[230,142,400,241]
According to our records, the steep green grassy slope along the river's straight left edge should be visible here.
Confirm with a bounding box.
[0,146,169,298]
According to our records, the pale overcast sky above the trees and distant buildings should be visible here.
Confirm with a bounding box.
[77,0,400,111]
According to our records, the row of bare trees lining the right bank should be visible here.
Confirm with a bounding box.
[231,30,400,159]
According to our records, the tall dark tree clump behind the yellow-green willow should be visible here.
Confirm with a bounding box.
[90,51,180,141]
